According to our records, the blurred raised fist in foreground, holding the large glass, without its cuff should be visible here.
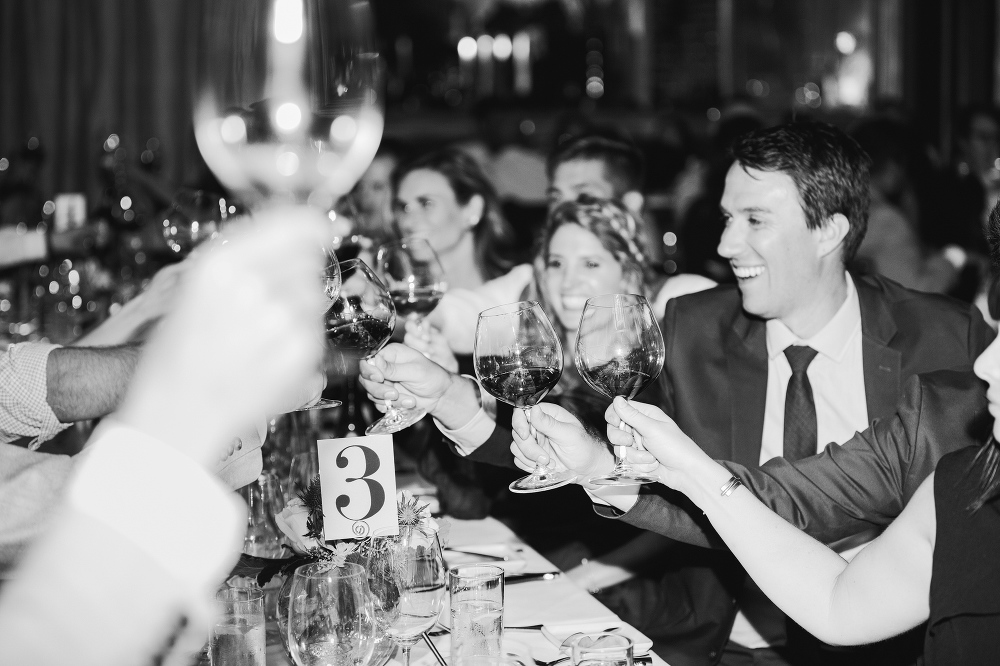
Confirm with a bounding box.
[119,207,328,464]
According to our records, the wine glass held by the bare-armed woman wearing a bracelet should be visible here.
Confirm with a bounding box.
[576,294,665,486]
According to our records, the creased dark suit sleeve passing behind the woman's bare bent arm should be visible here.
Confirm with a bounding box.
[598,370,989,546]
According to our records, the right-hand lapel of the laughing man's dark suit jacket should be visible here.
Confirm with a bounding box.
[854,278,902,421]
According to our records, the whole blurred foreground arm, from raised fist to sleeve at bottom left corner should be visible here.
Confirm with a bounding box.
[0,202,325,666]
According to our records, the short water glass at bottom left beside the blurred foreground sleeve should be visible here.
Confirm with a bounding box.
[209,587,266,666]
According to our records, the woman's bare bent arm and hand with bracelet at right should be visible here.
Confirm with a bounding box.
[614,399,935,645]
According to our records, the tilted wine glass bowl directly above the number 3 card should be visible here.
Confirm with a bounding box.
[325,259,396,382]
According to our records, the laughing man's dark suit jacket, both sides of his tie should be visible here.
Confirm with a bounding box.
[592,276,993,664]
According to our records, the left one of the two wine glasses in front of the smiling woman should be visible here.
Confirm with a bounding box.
[473,301,576,493]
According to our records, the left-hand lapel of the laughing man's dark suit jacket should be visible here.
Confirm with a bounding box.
[726,310,767,468]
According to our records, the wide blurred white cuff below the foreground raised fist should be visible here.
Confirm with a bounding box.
[68,421,247,599]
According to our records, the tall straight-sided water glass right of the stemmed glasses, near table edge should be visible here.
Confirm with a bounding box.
[448,564,503,663]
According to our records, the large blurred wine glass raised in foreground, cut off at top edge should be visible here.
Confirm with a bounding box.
[194,0,384,213]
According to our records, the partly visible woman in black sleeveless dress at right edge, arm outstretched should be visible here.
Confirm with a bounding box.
[608,294,1000,666]
